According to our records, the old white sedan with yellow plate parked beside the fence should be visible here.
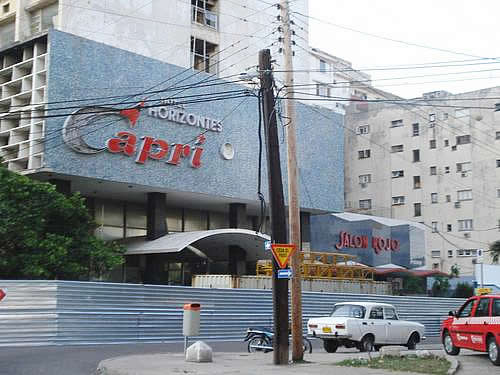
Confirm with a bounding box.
[307,302,425,353]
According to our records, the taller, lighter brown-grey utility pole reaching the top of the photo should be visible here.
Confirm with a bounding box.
[280,0,304,362]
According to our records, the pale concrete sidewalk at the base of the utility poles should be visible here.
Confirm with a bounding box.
[96,350,442,375]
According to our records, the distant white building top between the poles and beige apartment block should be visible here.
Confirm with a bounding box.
[306,47,399,114]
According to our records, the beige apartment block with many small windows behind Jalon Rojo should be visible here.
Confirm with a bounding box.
[345,87,500,275]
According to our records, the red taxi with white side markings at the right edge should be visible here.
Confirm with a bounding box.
[441,295,500,366]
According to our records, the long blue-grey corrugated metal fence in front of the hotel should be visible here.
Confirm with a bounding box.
[0,281,463,346]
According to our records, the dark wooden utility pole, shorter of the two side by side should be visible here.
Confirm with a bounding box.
[259,49,288,365]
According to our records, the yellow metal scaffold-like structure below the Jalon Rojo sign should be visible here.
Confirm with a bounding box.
[257,251,374,280]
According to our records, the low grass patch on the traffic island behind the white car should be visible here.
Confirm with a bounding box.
[336,355,451,375]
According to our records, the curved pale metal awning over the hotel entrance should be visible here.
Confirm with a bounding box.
[123,229,270,259]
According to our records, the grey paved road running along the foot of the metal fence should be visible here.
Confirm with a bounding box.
[0,339,490,375]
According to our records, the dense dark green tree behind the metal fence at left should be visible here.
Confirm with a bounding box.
[0,164,124,280]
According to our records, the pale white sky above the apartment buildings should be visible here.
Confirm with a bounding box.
[306,0,500,98]
